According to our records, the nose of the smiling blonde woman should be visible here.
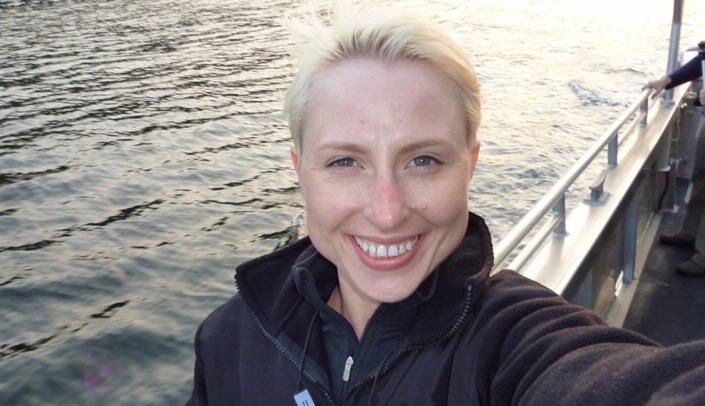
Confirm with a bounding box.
[360,174,409,231]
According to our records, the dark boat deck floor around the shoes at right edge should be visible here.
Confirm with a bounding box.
[623,179,705,345]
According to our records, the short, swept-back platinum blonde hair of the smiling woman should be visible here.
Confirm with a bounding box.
[284,1,481,151]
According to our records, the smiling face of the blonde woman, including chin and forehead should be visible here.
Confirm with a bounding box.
[291,57,479,306]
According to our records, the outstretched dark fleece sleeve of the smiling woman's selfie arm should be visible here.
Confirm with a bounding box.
[486,275,705,406]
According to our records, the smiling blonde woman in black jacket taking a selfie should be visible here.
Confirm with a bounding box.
[190,4,705,406]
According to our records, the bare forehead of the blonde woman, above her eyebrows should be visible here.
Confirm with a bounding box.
[303,57,465,150]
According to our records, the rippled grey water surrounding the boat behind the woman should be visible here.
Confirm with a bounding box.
[0,0,703,405]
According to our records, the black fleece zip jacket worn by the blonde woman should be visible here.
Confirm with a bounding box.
[188,214,705,406]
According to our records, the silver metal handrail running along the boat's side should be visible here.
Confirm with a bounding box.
[492,90,651,273]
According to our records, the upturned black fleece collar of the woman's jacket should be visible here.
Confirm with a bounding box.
[235,213,494,345]
